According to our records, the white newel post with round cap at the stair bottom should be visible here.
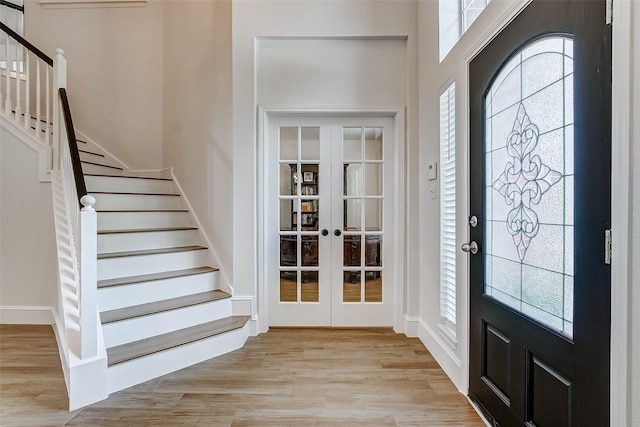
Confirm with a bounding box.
[78,194,98,359]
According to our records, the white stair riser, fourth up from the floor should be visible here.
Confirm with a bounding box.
[98,250,208,280]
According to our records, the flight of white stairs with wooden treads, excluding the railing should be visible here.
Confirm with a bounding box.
[79,141,249,393]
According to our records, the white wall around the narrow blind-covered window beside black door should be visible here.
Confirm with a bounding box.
[414,0,523,393]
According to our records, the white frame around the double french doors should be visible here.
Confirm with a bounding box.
[252,106,407,333]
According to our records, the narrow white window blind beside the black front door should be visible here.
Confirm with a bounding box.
[440,83,456,340]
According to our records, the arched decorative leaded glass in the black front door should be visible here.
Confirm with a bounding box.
[484,35,574,337]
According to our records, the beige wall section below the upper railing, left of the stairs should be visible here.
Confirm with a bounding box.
[0,126,58,323]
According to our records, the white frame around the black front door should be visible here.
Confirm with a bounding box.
[452,0,634,426]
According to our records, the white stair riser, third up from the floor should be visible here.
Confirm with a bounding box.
[98,272,218,311]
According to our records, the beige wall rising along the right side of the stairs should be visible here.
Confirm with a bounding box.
[161,1,234,285]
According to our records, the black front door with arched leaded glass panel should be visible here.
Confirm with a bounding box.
[463,0,611,426]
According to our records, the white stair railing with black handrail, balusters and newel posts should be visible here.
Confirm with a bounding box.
[0,22,107,409]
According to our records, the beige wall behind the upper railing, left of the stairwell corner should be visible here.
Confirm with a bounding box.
[24,0,164,169]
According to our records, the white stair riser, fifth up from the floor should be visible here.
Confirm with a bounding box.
[98,230,200,253]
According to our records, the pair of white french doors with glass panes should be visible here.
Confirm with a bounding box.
[266,115,394,326]
